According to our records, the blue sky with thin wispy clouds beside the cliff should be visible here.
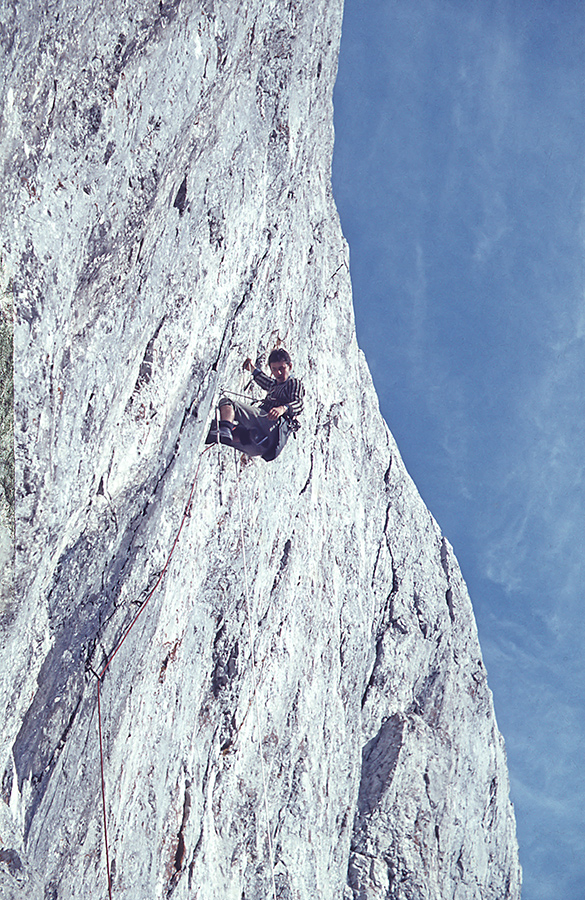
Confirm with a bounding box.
[333,0,585,900]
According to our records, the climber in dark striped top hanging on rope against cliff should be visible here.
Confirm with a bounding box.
[206,347,305,462]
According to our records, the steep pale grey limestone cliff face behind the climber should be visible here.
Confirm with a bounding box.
[0,0,520,900]
